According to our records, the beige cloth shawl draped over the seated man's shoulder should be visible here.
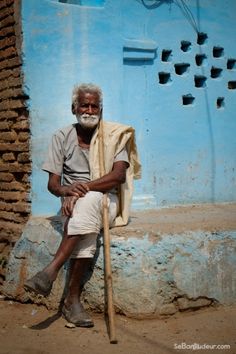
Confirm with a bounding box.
[89,121,141,226]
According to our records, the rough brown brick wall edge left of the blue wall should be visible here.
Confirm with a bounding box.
[0,0,31,286]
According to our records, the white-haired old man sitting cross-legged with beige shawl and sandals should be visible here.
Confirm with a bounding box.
[24,84,140,327]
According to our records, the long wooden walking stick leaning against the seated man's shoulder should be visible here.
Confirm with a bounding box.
[98,119,117,344]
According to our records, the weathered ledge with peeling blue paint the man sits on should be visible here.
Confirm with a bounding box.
[4,204,236,318]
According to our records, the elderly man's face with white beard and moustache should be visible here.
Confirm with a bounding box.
[76,93,101,129]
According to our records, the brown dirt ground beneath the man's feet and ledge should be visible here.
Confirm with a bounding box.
[0,300,236,354]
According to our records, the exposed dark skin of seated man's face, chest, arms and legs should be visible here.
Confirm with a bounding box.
[40,93,128,312]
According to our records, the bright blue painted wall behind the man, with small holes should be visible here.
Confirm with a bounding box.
[22,0,236,215]
